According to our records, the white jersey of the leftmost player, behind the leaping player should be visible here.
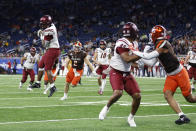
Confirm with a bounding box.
[24,53,39,69]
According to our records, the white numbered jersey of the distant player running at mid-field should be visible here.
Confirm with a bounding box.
[96,48,111,65]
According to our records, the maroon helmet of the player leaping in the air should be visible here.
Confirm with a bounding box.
[39,15,52,30]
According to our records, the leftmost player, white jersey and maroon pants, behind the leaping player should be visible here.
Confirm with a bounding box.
[19,47,40,91]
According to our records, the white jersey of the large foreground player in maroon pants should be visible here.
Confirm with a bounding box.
[110,38,138,72]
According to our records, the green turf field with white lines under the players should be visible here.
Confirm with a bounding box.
[0,75,196,131]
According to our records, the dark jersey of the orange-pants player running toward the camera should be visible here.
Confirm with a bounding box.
[68,50,87,70]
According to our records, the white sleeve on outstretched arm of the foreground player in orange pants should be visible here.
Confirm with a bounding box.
[133,50,159,59]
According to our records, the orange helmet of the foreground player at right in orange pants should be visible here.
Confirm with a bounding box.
[149,25,167,43]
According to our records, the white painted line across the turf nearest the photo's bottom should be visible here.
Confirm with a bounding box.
[0,113,196,125]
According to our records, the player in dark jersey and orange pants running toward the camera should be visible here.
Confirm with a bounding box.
[60,41,94,100]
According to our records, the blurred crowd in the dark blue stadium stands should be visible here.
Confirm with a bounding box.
[0,0,196,57]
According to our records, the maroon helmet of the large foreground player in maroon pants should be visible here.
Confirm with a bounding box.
[122,22,139,40]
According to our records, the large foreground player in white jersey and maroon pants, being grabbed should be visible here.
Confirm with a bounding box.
[99,22,141,127]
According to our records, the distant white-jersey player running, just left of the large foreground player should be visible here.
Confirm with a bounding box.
[94,40,111,95]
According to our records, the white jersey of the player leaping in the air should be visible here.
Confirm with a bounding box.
[40,24,60,49]
